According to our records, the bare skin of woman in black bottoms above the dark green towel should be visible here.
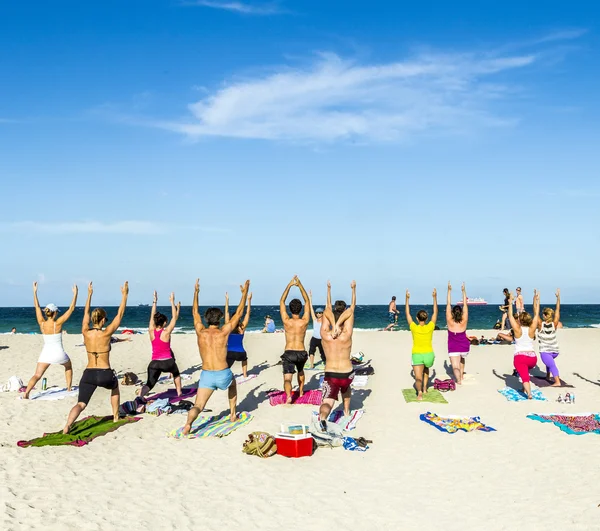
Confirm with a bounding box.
[63,281,129,433]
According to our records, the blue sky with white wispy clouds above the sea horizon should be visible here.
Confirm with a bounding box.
[0,0,600,306]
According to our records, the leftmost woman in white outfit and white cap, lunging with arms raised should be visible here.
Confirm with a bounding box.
[23,282,77,399]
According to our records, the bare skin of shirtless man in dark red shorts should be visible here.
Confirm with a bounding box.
[319,280,356,420]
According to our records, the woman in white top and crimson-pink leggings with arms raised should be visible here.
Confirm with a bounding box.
[508,291,540,400]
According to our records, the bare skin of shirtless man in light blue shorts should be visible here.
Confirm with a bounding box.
[183,280,250,435]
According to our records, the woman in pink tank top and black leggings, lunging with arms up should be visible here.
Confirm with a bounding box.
[138,291,181,397]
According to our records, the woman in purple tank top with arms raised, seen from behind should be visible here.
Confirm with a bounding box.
[446,282,471,385]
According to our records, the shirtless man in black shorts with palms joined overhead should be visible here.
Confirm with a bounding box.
[279,276,310,404]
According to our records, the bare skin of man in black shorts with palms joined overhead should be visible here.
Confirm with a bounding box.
[279,275,310,404]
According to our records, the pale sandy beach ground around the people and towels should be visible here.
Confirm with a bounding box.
[0,329,600,530]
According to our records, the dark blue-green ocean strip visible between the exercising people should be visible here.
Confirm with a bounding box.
[0,304,600,334]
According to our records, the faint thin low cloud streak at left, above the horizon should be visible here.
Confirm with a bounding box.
[0,221,229,235]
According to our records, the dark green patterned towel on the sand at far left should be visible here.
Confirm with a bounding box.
[17,416,141,448]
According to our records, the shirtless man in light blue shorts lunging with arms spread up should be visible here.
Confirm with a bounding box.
[183,280,250,435]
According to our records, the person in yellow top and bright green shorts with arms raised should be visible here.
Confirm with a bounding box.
[405,288,437,400]
